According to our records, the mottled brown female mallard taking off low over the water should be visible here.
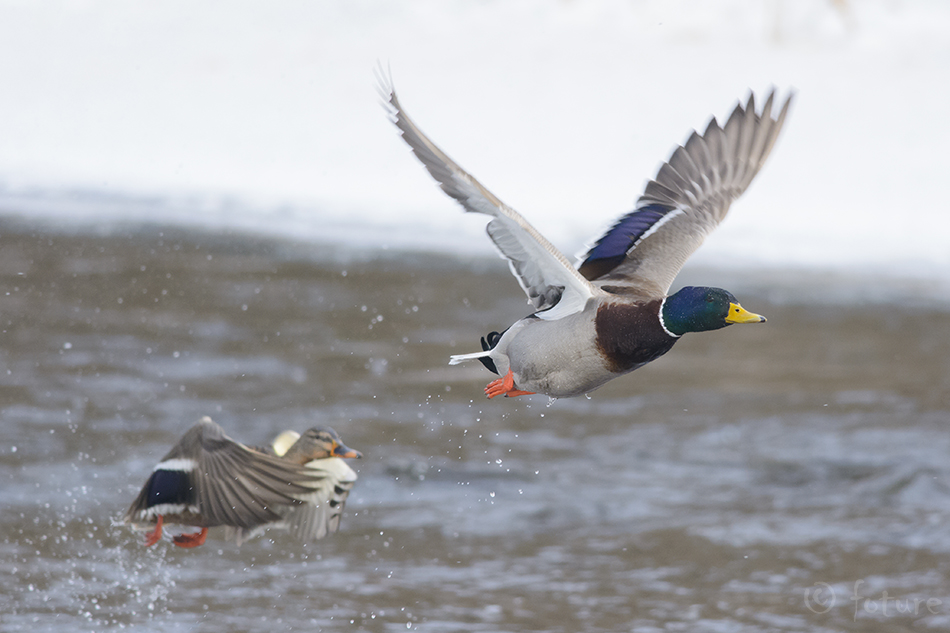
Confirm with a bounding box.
[125,417,360,547]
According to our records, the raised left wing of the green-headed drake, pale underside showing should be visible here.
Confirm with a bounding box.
[377,72,596,320]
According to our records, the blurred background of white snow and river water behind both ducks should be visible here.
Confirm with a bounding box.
[0,0,950,632]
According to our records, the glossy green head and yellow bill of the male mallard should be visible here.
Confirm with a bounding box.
[660,286,765,336]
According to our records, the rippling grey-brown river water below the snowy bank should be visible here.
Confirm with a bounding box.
[0,219,950,632]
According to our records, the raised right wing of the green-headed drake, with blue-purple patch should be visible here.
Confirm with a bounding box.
[579,90,792,296]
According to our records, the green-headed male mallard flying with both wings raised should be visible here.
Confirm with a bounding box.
[380,74,791,398]
